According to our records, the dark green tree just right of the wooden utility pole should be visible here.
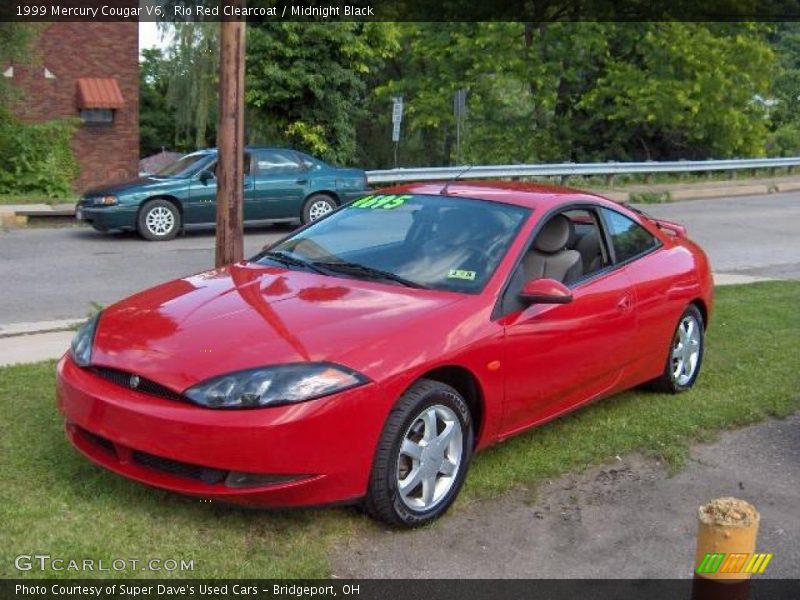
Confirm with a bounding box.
[245,22,394,163]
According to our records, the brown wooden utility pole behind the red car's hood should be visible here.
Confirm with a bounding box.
[215,0,245,267]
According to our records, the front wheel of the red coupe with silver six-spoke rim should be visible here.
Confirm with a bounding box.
[364,379,474,527]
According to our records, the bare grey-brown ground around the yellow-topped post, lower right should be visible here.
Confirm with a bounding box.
[333,414,800,578]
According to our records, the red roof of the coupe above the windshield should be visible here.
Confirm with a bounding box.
[380,181,620,208]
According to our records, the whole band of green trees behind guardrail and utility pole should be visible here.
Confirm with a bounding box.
[142,22,800,168]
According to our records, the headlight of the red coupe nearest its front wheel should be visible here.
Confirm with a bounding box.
[183,363,369,408]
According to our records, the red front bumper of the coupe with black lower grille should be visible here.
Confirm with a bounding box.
[56,356,386,507]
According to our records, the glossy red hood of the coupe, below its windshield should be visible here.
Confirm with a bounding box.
[92,263,463,391]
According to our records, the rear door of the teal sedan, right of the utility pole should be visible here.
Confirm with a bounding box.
[248,150,308,219]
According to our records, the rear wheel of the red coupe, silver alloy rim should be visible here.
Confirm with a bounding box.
[647,304,705,394]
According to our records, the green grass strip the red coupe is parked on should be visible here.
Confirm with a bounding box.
[0,282,800,578]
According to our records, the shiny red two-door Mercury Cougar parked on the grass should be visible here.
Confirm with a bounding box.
[58,182,713,526]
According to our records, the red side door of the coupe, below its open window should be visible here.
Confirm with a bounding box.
[503,208,636,435]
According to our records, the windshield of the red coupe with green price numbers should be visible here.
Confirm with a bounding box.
[253,194,530,293]
